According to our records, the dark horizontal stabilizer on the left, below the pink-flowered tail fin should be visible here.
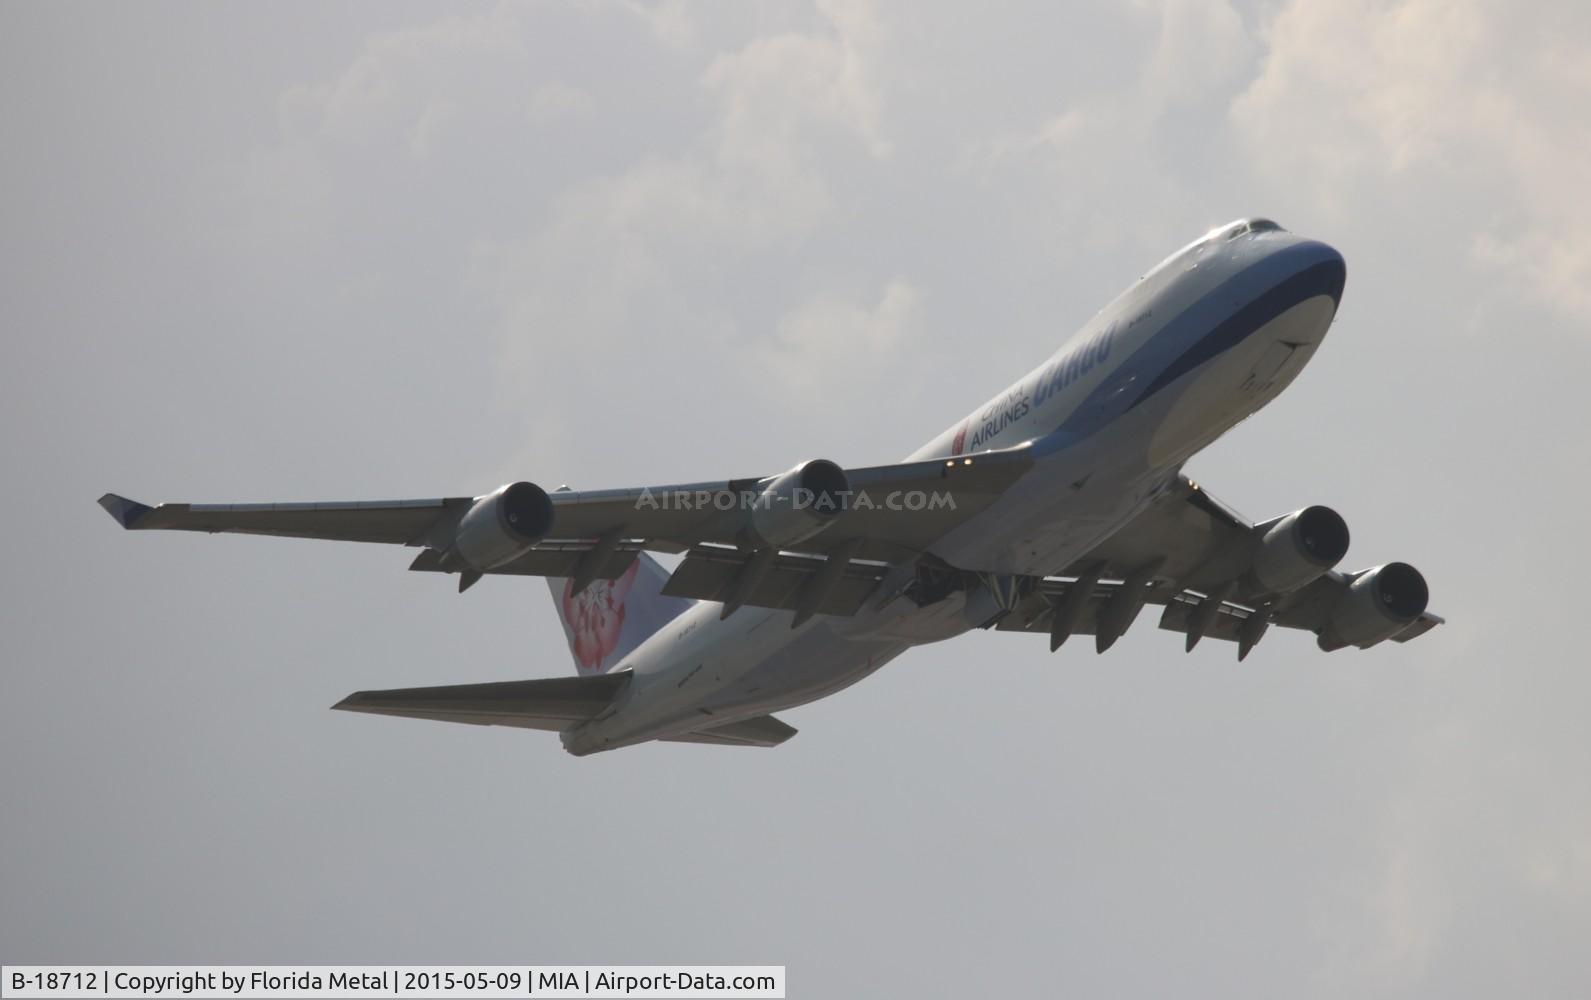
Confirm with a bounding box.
[331,672,630,731]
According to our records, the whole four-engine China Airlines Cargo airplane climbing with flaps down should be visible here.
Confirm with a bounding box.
[100,219,1441,755]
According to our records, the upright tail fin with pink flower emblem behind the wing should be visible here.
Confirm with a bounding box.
[547,552,695,674]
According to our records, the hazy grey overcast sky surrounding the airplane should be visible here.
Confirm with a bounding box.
[0,0,1591,997]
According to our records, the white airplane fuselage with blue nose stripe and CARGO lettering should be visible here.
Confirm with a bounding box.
[563,219,1344,755]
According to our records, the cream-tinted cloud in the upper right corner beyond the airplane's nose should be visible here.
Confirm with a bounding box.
[1231,0,1591,320]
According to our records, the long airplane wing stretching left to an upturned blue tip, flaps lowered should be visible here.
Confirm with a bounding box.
[99,445,1033,597]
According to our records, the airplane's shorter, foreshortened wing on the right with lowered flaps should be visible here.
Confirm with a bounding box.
[994,477,1443,660]
